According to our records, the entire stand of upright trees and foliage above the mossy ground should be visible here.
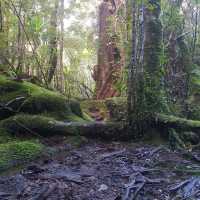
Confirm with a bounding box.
[0,0,200,144]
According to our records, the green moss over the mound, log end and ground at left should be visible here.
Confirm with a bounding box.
[0,75,91,170]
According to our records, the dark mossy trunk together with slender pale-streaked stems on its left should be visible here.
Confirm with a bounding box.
[128,0,162,137]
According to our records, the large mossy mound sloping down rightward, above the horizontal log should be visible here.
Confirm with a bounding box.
[0,75,84,121]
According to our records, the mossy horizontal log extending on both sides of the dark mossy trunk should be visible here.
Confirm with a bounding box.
[0,114,200,144]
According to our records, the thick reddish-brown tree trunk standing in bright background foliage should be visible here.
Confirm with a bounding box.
[93,0,122,99]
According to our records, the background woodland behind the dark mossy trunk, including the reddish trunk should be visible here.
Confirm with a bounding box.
[0,0,200,114]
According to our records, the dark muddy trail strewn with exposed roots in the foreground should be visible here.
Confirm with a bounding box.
[0,140,200,200]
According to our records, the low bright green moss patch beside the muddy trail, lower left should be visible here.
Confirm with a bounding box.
[0,141,43,170]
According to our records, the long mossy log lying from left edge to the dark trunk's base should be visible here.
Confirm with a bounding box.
[0,115,131,140]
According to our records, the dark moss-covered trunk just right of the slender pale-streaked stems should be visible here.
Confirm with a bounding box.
[144,0,162,112]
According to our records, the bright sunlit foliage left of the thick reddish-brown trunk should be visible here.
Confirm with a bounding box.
[0,0,97,98]
